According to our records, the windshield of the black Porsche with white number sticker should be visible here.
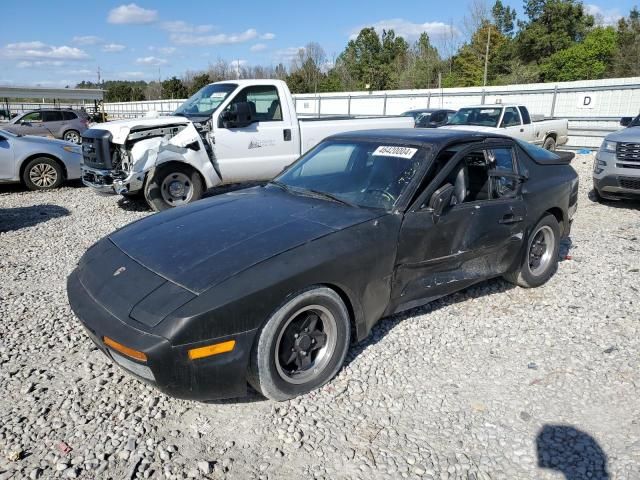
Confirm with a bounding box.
[273,140,425,210]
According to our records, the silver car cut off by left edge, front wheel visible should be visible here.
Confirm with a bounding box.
[0,130,82,190]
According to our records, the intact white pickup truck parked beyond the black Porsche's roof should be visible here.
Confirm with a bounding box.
[440,104,569,150]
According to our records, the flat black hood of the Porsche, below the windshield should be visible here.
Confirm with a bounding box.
[109,187,380,294]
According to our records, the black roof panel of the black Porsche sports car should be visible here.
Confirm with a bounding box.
[327,128,512,147]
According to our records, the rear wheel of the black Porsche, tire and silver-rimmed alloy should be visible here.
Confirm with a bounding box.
[504,215,560,288]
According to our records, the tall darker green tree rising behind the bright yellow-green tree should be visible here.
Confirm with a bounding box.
[516,0,594,64]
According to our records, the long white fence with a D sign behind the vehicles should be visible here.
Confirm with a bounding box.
[12,77,640,148]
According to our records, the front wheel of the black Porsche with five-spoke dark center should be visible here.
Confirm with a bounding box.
[247,287,351,402]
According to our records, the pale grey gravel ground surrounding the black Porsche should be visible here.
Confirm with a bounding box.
[0,156,640,480]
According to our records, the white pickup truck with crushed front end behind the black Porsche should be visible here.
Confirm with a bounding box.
[82,80,413,210]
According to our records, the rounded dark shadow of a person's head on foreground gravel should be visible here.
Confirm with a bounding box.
[536,425,609,480]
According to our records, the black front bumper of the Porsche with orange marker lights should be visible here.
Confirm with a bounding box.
[67,271,256,401]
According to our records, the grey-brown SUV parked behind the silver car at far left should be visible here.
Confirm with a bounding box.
[2,108,89,144]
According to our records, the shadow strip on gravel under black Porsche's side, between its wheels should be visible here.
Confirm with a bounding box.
[342,278,516,368]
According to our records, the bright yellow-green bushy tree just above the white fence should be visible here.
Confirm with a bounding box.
[541,27,617,82]
